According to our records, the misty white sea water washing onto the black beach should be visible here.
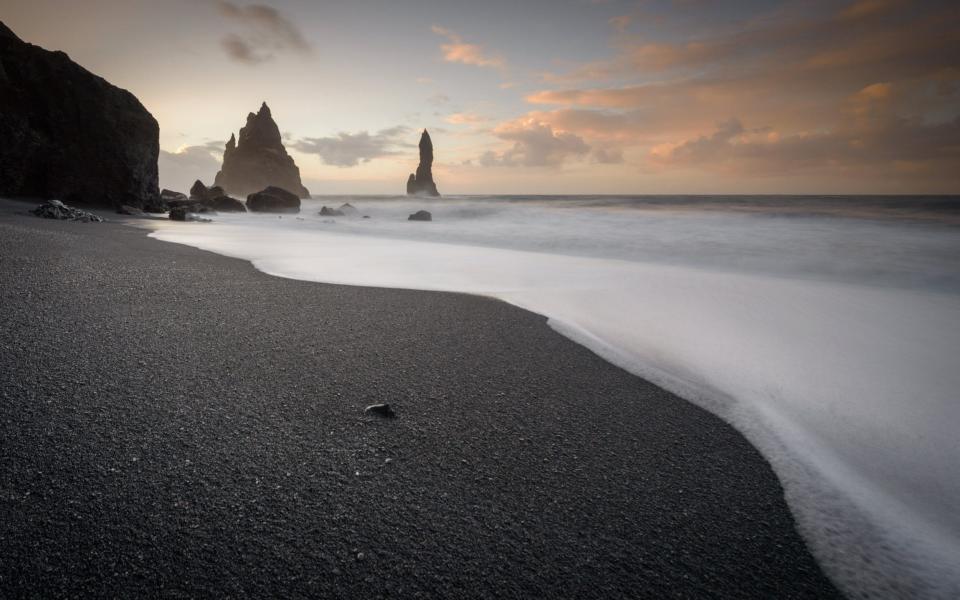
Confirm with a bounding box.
[151,196,960,598]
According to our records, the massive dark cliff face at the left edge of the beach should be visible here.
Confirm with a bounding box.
[0,22,160,208]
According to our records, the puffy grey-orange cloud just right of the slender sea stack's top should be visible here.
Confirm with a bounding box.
[478,118,590,167]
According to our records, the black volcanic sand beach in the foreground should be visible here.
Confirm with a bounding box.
[0,202,837,598]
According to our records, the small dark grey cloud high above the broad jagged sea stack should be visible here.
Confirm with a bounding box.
[217,0,313,65]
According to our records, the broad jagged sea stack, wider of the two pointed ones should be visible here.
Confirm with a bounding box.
[213,102,310,198]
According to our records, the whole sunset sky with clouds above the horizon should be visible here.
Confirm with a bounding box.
[0,0,960,194]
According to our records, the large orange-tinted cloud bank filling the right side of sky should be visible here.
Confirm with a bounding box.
[512,0,960,187]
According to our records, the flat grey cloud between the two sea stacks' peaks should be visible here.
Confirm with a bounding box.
[293,125,414,167]
